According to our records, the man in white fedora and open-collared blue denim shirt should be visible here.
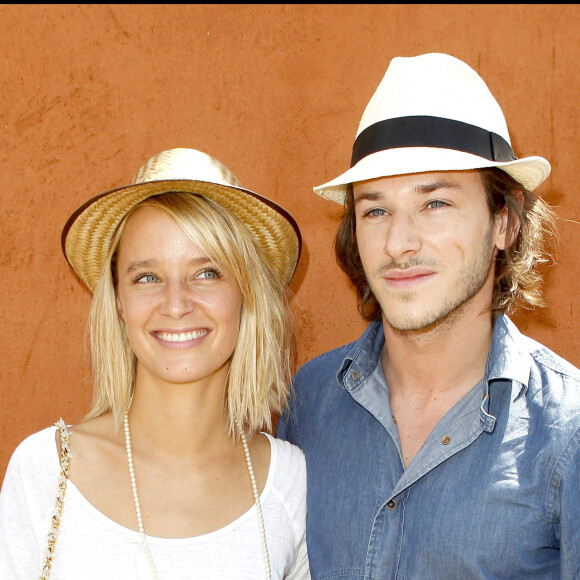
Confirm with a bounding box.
[278,54,580,580]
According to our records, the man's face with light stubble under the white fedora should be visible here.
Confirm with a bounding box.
[353,171,507,330]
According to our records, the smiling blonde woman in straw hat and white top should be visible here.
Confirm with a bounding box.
[0,149,310,579]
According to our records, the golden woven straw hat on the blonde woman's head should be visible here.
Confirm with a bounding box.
[62,149,301,292]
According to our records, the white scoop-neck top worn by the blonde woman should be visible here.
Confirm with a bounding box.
[0,427,310,580]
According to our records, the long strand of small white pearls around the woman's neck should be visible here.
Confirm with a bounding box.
[124,411,272,580]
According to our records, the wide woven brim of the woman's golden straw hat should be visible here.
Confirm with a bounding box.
[61,179,302,292]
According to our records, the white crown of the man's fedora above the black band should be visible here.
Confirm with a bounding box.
[357,53,511,144]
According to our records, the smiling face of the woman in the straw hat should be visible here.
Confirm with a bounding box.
[117,206,242,385]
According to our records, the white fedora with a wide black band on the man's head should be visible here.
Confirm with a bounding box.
[314,53,550,203]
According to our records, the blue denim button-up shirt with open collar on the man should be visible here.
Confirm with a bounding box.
[277,317,580,580]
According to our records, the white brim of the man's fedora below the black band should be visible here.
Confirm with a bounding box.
[314,147,551,204]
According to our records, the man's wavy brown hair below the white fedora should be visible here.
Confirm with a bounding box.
[334,168,557,321]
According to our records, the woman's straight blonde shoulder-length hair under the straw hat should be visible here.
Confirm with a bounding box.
[87,192,293,435]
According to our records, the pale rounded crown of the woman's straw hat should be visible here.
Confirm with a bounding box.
[132,148,241,187]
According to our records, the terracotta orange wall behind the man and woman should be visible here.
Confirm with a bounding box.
[0,5,580,478]
